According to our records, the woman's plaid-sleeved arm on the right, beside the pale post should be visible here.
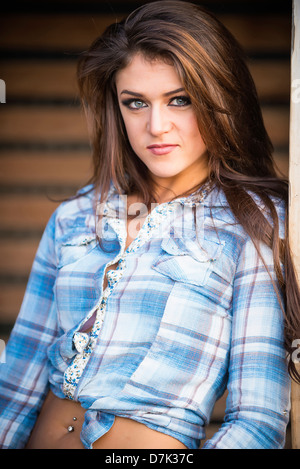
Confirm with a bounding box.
[203,240,290,449]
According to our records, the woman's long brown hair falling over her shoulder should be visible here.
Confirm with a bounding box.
[78,0,300,383]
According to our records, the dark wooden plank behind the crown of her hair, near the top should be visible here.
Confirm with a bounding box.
[0,13,290,53]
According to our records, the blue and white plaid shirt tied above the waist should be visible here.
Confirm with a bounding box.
[0,182,290,449]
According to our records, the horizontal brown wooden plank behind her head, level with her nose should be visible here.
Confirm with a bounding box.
[0,105,289,145]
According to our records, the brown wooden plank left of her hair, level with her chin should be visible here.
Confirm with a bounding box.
[0,150,92,187]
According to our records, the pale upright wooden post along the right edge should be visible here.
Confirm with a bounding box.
[289,0,300,449]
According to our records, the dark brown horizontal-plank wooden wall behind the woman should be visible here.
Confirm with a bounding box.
[0,0,291,448]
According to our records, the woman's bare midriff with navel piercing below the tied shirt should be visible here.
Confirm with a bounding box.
[26,391,186,449]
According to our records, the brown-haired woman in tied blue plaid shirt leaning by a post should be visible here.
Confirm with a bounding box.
[0,1,300,449]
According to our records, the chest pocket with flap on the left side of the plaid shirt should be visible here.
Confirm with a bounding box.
[59,233,97,267]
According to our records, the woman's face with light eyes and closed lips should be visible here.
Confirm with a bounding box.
[116,54,208,196]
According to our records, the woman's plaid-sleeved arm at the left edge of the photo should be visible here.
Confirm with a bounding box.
[0,213,57,448]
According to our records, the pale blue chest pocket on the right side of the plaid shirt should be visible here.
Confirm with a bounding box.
[153,237,224,286]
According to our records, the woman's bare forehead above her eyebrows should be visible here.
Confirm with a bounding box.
[116,54,183,94]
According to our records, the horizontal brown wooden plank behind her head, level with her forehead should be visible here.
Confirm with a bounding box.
[0,60,290,101]
